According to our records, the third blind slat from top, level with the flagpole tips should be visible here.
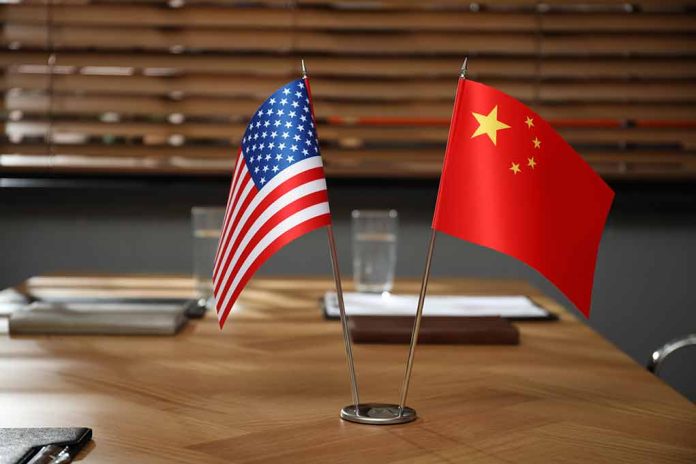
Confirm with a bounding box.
[8,51,696,79]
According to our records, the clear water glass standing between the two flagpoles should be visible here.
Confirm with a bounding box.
[351,209,399,293]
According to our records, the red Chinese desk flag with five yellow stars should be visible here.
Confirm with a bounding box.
[433,79,614,316]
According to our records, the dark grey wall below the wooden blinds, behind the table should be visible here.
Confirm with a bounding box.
[0,179,696,401]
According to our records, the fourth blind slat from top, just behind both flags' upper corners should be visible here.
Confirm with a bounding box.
[5,74,696,102]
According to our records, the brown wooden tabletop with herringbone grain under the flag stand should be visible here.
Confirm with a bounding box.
[0,277,696,464]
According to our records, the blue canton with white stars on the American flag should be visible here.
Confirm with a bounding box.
[242,79,319,189]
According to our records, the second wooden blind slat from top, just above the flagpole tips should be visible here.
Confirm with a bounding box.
[4,24,696,56]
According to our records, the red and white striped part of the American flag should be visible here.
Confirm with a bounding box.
[213,152,331,327]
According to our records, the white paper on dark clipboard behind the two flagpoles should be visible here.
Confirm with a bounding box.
[324,292,549,318]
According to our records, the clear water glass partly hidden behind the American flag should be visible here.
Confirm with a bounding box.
[191,206,225,308]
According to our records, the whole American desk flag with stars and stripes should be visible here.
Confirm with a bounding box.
[213,79,331,327]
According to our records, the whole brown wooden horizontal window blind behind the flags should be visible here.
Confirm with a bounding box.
[0,0,696,180]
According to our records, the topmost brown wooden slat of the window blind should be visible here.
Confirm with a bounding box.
[4,4,696,33]
